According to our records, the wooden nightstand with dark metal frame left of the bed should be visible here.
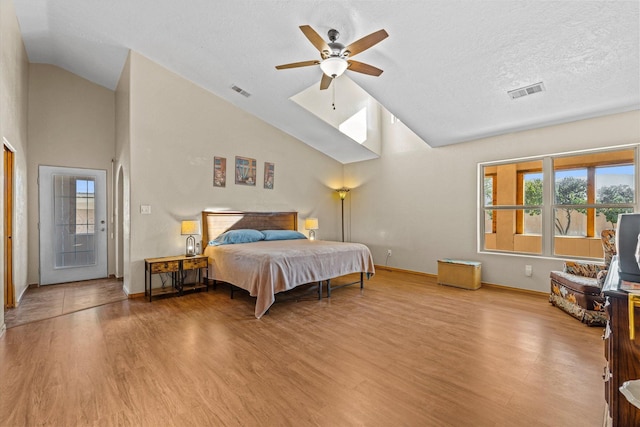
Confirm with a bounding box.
[144,255,209,302]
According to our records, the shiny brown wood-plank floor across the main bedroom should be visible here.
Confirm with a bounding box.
[0,270,604,427]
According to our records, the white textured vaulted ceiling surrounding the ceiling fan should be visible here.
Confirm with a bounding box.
[14,0,640,163]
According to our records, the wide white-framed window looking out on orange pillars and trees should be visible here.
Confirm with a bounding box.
[479,148,637,258]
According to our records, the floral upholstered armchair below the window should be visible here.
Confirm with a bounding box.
[549,230,616,326]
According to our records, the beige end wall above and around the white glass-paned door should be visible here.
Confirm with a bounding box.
[28,64,115,284]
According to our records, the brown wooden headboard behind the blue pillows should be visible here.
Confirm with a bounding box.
[202,211,298,248]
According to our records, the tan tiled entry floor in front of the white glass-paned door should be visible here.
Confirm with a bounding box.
[4,278,127,328]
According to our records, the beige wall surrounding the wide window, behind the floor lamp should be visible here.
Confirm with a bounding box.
[345,111,640,291]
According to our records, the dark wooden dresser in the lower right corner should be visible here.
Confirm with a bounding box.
[602,258,640,427]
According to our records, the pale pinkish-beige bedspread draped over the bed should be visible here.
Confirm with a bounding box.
[205,239,375,318]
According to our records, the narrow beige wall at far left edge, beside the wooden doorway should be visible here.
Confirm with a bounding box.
[0,0,29,335]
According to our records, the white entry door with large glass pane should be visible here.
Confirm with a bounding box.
[38,166,107,285]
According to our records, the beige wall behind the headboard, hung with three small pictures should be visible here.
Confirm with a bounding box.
[124,53,343,293]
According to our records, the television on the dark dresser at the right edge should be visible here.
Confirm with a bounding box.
[616,213,640,282]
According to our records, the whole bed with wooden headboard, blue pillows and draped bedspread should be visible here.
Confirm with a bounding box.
[202,211,375,319]
